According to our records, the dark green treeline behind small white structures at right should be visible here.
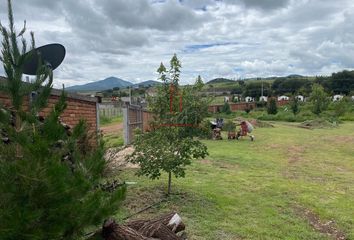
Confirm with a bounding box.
[221,70,354,98]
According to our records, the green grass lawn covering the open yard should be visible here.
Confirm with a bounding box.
[116,122,354,240]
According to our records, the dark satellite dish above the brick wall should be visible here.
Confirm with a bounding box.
[23,43,65,75]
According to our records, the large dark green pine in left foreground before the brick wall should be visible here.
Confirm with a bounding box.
[0,0,125,240]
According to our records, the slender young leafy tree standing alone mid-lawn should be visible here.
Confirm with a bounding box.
[128,55,208,194]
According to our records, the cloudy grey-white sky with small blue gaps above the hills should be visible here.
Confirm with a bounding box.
[0,0,354,86]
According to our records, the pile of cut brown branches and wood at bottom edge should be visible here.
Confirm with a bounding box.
[102,213,185,240]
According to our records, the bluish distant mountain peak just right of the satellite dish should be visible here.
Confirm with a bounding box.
[66,77,133,92]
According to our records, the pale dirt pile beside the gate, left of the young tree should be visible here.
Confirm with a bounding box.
[104,147,139,171]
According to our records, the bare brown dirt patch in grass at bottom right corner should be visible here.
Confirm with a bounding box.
[293,205,347,240]
